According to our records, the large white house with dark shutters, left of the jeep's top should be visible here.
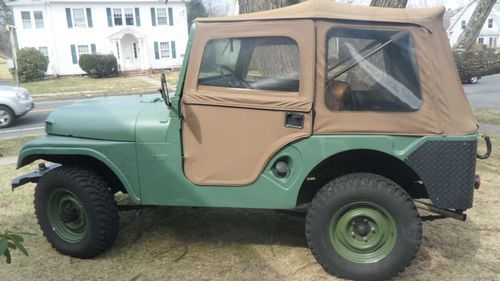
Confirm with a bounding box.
[8,0,188,75]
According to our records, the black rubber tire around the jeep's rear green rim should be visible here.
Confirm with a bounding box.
[306,173,422,280]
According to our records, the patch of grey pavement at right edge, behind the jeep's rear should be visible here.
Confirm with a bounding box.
[464,74,500,109]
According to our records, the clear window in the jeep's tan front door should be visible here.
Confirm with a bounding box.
[198,37,300,92]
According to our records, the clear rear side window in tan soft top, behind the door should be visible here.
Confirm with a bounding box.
[325,28,422,112]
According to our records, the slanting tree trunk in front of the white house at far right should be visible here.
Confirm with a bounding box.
[453,0,497,50]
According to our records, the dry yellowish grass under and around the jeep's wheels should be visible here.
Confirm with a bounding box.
[0,136,500,281]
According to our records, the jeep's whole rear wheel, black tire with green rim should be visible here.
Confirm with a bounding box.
[306,173,422,280]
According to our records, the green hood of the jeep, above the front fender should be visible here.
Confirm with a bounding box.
[45,95,168,141]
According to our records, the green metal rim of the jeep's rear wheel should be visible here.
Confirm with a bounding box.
[329,202,397,263]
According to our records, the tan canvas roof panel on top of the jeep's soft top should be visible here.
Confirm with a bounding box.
[196,0,445,30]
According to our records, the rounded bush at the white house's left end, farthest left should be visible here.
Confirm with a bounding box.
[17,48,49,81]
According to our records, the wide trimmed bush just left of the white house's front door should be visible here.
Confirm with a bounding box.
[80,55,118,78]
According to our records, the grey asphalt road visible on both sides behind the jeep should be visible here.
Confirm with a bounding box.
[0,75,500,139]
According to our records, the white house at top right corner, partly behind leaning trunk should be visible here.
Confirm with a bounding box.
[448,0,500,48]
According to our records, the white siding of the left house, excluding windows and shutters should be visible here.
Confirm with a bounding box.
[12,1,188,75]
